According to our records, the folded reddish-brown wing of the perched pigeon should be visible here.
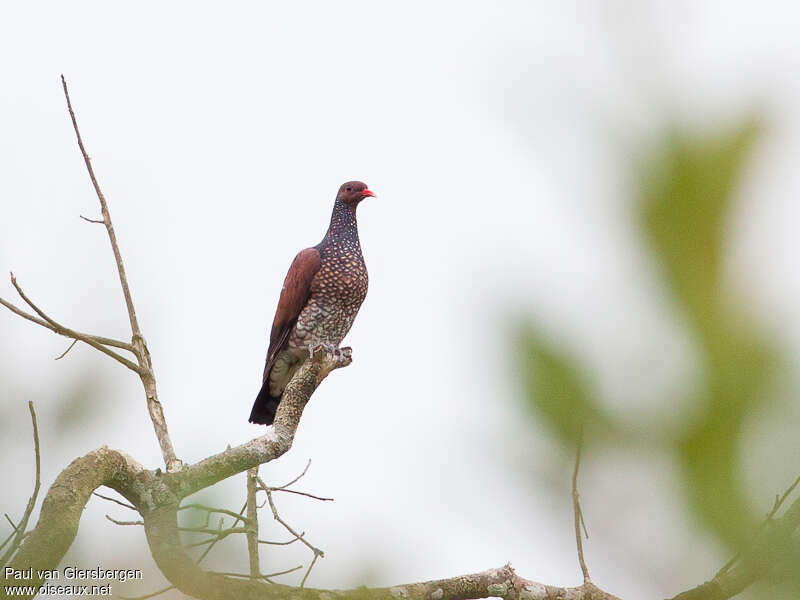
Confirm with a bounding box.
[263,248,321,381]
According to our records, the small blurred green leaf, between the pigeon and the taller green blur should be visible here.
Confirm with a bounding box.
[517,327,610,446]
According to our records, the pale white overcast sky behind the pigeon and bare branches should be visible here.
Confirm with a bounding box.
[0,1,800,597]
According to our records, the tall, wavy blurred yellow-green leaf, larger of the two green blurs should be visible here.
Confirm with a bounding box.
[640,121,773,548]
